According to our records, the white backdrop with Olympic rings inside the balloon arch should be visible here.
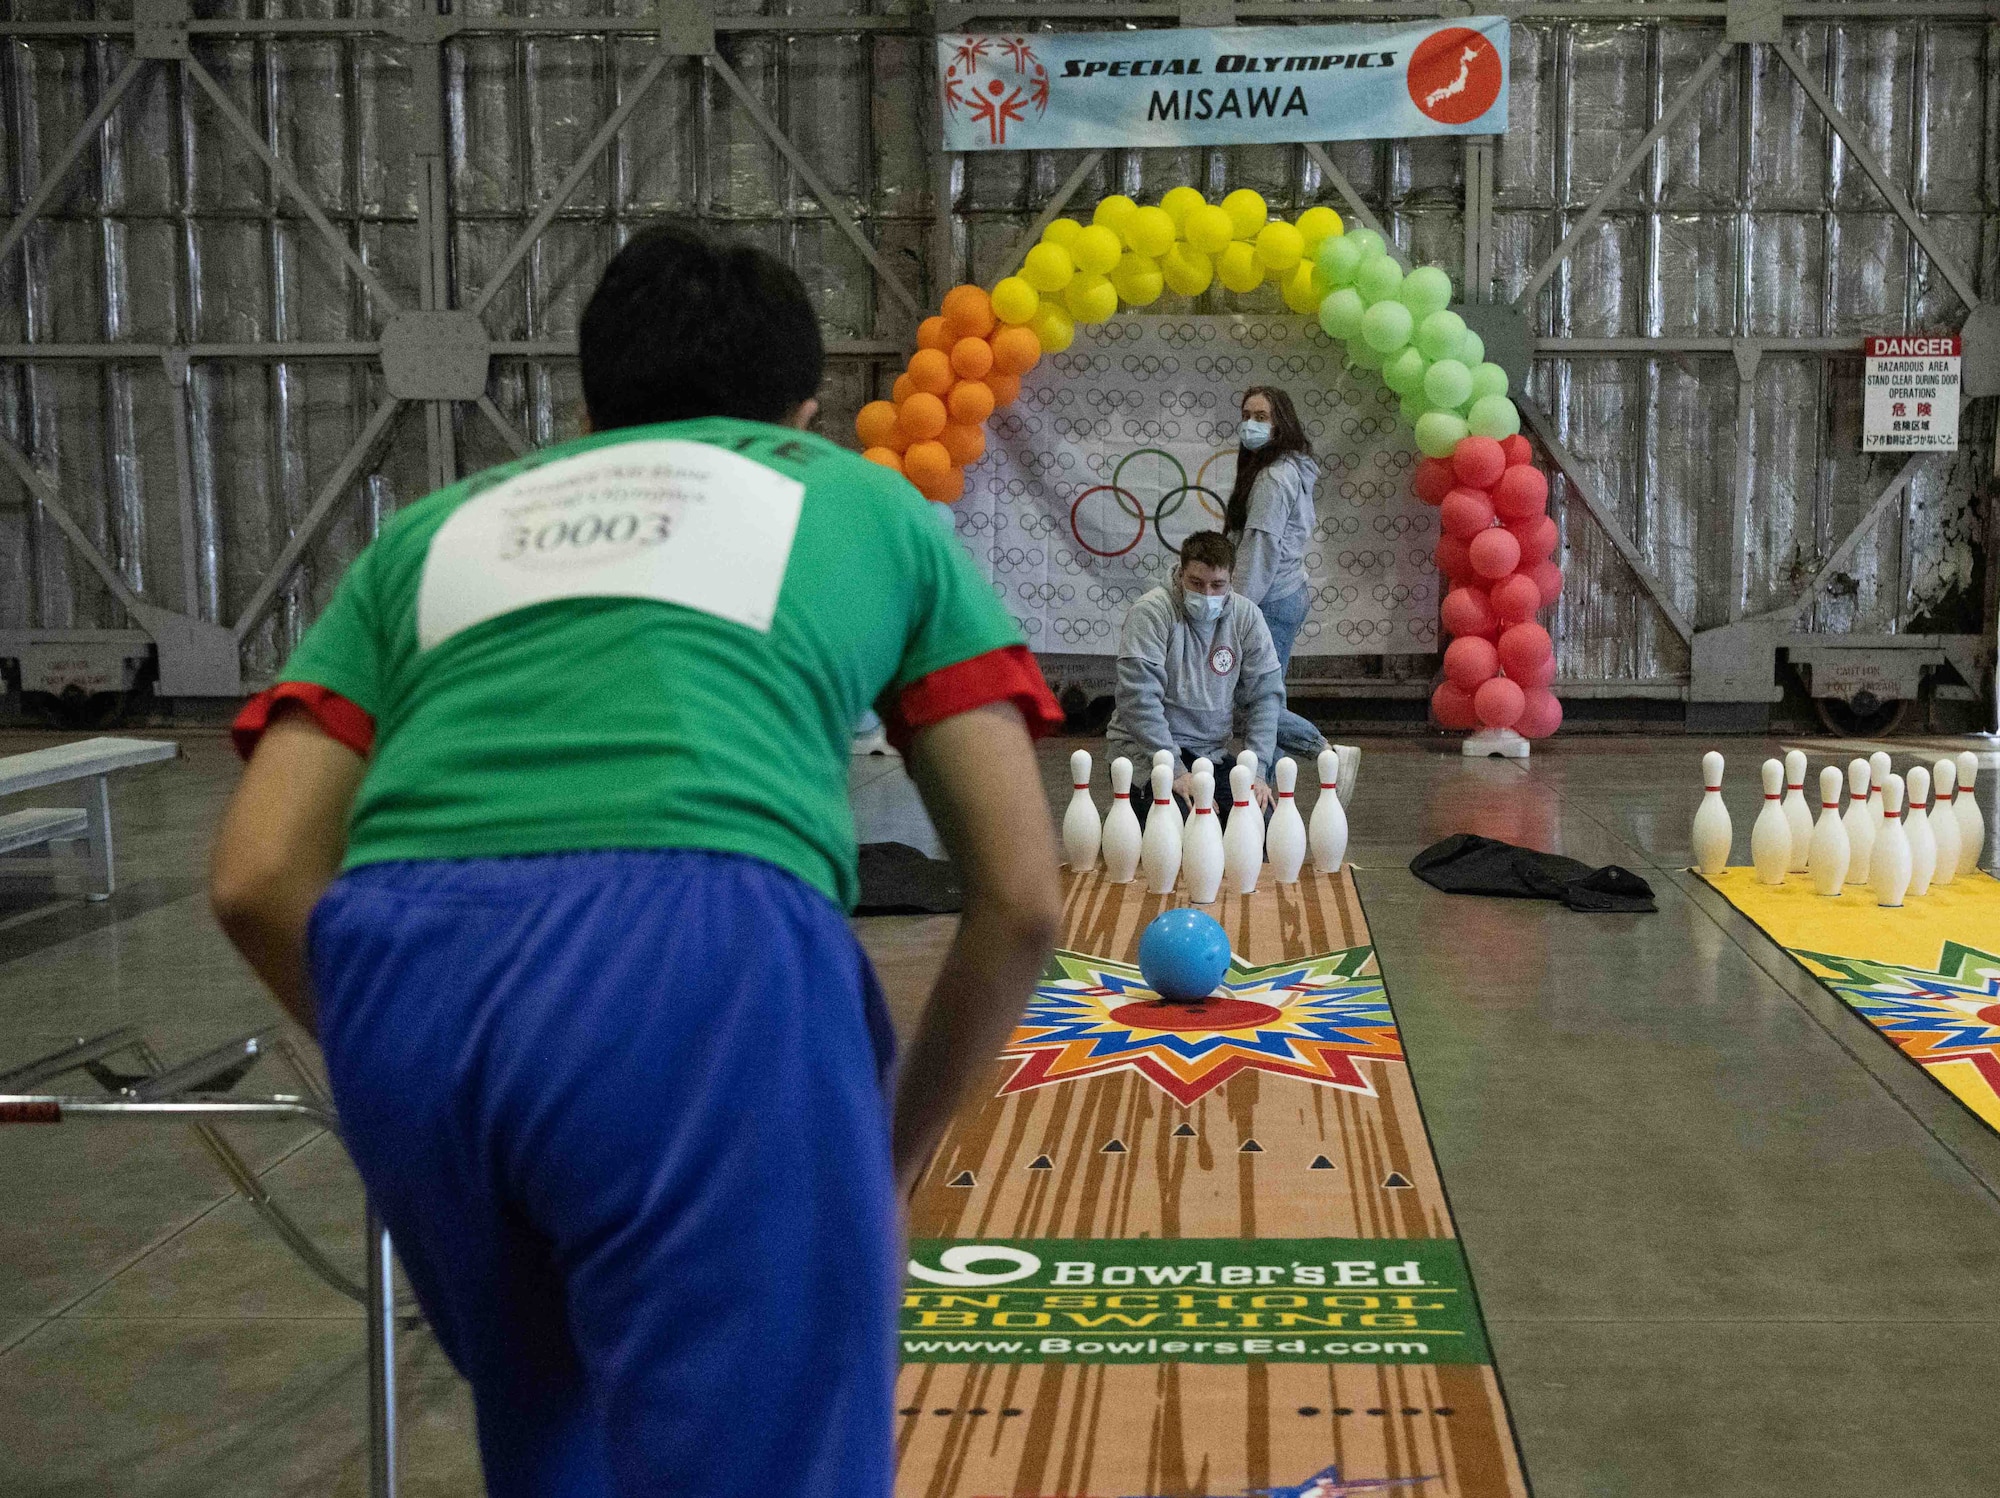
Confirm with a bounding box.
[956,316,1438,656]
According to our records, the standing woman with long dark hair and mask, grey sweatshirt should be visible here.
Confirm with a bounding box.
[1222,384,1326,754]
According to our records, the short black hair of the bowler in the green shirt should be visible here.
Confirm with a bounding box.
[576,222,826,432]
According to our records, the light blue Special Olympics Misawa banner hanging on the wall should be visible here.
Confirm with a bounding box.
[938,16,1508,150]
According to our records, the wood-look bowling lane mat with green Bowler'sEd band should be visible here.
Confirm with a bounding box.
[898,874,1528,1498]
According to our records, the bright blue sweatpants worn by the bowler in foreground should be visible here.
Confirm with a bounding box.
[310,850,900,1498]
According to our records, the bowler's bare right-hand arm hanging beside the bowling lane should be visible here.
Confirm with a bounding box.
[890,702,1062,1196]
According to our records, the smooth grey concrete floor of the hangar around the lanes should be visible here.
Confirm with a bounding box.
[0,720,2000,1498]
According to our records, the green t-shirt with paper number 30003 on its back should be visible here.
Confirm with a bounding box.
[280,418,1022,908]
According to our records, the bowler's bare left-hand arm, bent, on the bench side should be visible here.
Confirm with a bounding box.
[208,704,368,1030]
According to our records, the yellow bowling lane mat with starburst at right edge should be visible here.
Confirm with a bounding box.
[1702,868,2000,1132]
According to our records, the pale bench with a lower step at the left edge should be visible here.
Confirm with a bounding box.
[0,738,180,900]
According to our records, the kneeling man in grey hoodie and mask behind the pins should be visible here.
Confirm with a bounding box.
[1104,530,1284,820]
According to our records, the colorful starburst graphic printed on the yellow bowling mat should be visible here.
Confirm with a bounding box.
[1794,942,2000,1092]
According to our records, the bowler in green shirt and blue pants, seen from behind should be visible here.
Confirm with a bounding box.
[212,228,1060,1496]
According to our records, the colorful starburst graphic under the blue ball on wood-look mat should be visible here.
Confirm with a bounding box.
[1000,946,1402,1104]
